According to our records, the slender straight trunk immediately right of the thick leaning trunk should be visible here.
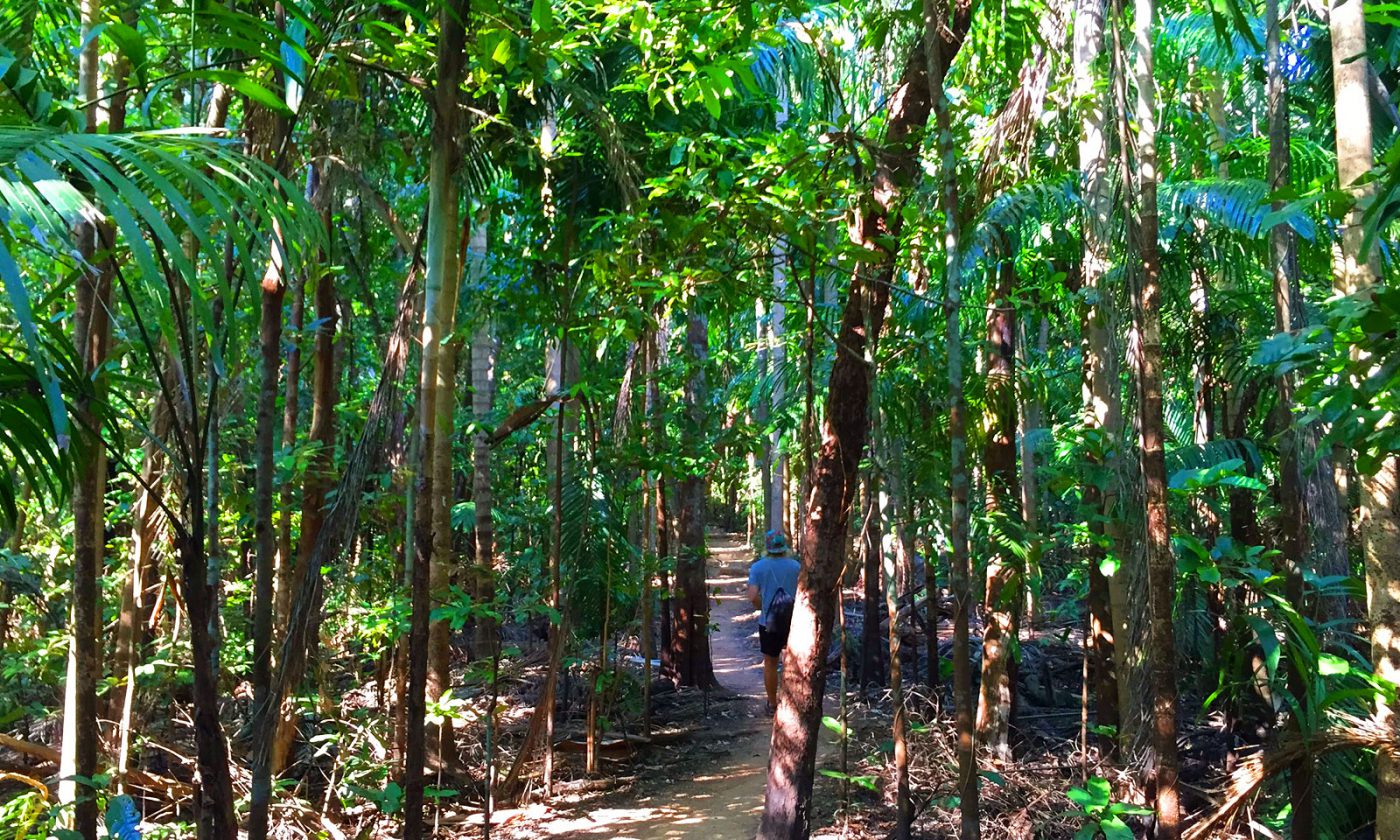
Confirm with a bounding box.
[923,0,981,840]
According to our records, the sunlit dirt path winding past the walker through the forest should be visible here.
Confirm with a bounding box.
[515,533,769,840]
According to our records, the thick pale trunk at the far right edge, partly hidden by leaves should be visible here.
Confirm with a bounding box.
[1329,0,1400,837]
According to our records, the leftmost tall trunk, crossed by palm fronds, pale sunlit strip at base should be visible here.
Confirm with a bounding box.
[59,0,112,837]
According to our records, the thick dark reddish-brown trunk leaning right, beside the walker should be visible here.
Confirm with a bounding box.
[759,24,969,840]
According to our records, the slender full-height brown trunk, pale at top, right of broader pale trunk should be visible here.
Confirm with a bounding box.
[1130,0,1182,840]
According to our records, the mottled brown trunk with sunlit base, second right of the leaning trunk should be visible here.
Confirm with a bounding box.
[977,256,1022,763]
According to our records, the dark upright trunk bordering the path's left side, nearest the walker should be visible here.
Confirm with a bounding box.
[673,312,715,687]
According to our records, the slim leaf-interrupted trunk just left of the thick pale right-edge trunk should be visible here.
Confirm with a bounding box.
[1264,0,1313,840]
